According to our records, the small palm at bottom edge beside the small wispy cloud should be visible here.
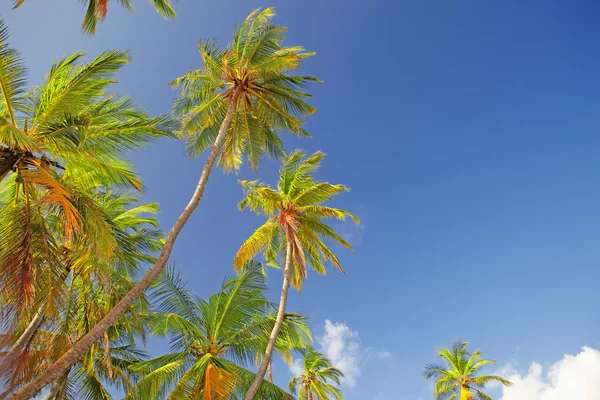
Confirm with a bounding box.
[289,349,344,400]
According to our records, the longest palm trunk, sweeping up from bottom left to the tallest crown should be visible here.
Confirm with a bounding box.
[9,89,240,400]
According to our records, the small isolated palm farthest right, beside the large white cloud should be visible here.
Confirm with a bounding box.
[425,340,511,400]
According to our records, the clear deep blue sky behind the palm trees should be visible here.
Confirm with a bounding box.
[0,0,600,400]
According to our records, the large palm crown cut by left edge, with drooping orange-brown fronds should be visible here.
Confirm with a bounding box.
[0,21,173,322]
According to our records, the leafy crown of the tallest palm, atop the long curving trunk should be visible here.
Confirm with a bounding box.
[173,8,319,170]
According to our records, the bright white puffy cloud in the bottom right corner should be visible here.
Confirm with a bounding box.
[501,347,600,400]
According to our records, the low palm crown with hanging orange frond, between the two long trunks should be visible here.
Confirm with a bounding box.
[123,262,308,399]
